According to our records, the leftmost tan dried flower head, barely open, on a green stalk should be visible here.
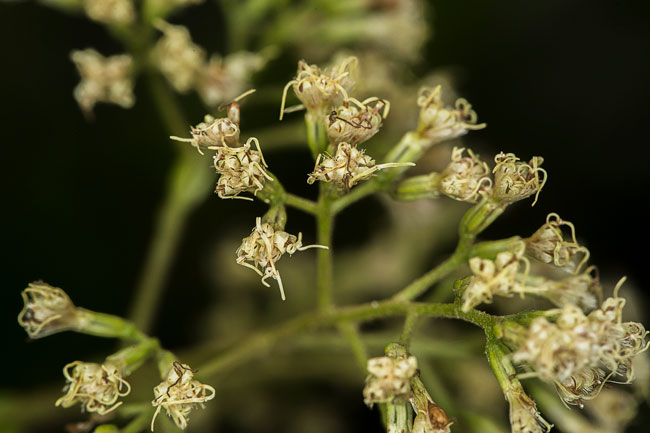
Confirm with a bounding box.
[18,281,79,338]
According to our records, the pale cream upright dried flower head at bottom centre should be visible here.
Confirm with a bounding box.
[363,356,418,407]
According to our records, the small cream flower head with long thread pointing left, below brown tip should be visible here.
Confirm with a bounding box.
[169,114,239,155]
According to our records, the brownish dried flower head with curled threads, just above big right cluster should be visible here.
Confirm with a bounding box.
[525,213,589,273]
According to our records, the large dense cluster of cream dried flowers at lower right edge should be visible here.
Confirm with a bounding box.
[512,281,648,405]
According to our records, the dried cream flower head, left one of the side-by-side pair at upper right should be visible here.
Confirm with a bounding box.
[439,147,492,203]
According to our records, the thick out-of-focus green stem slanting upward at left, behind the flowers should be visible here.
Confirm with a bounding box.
[129,73,214,332]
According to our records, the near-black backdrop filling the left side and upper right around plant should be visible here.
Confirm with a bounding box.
[0,0,650,431]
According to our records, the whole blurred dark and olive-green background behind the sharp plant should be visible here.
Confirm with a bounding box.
[0,0,650,432]
